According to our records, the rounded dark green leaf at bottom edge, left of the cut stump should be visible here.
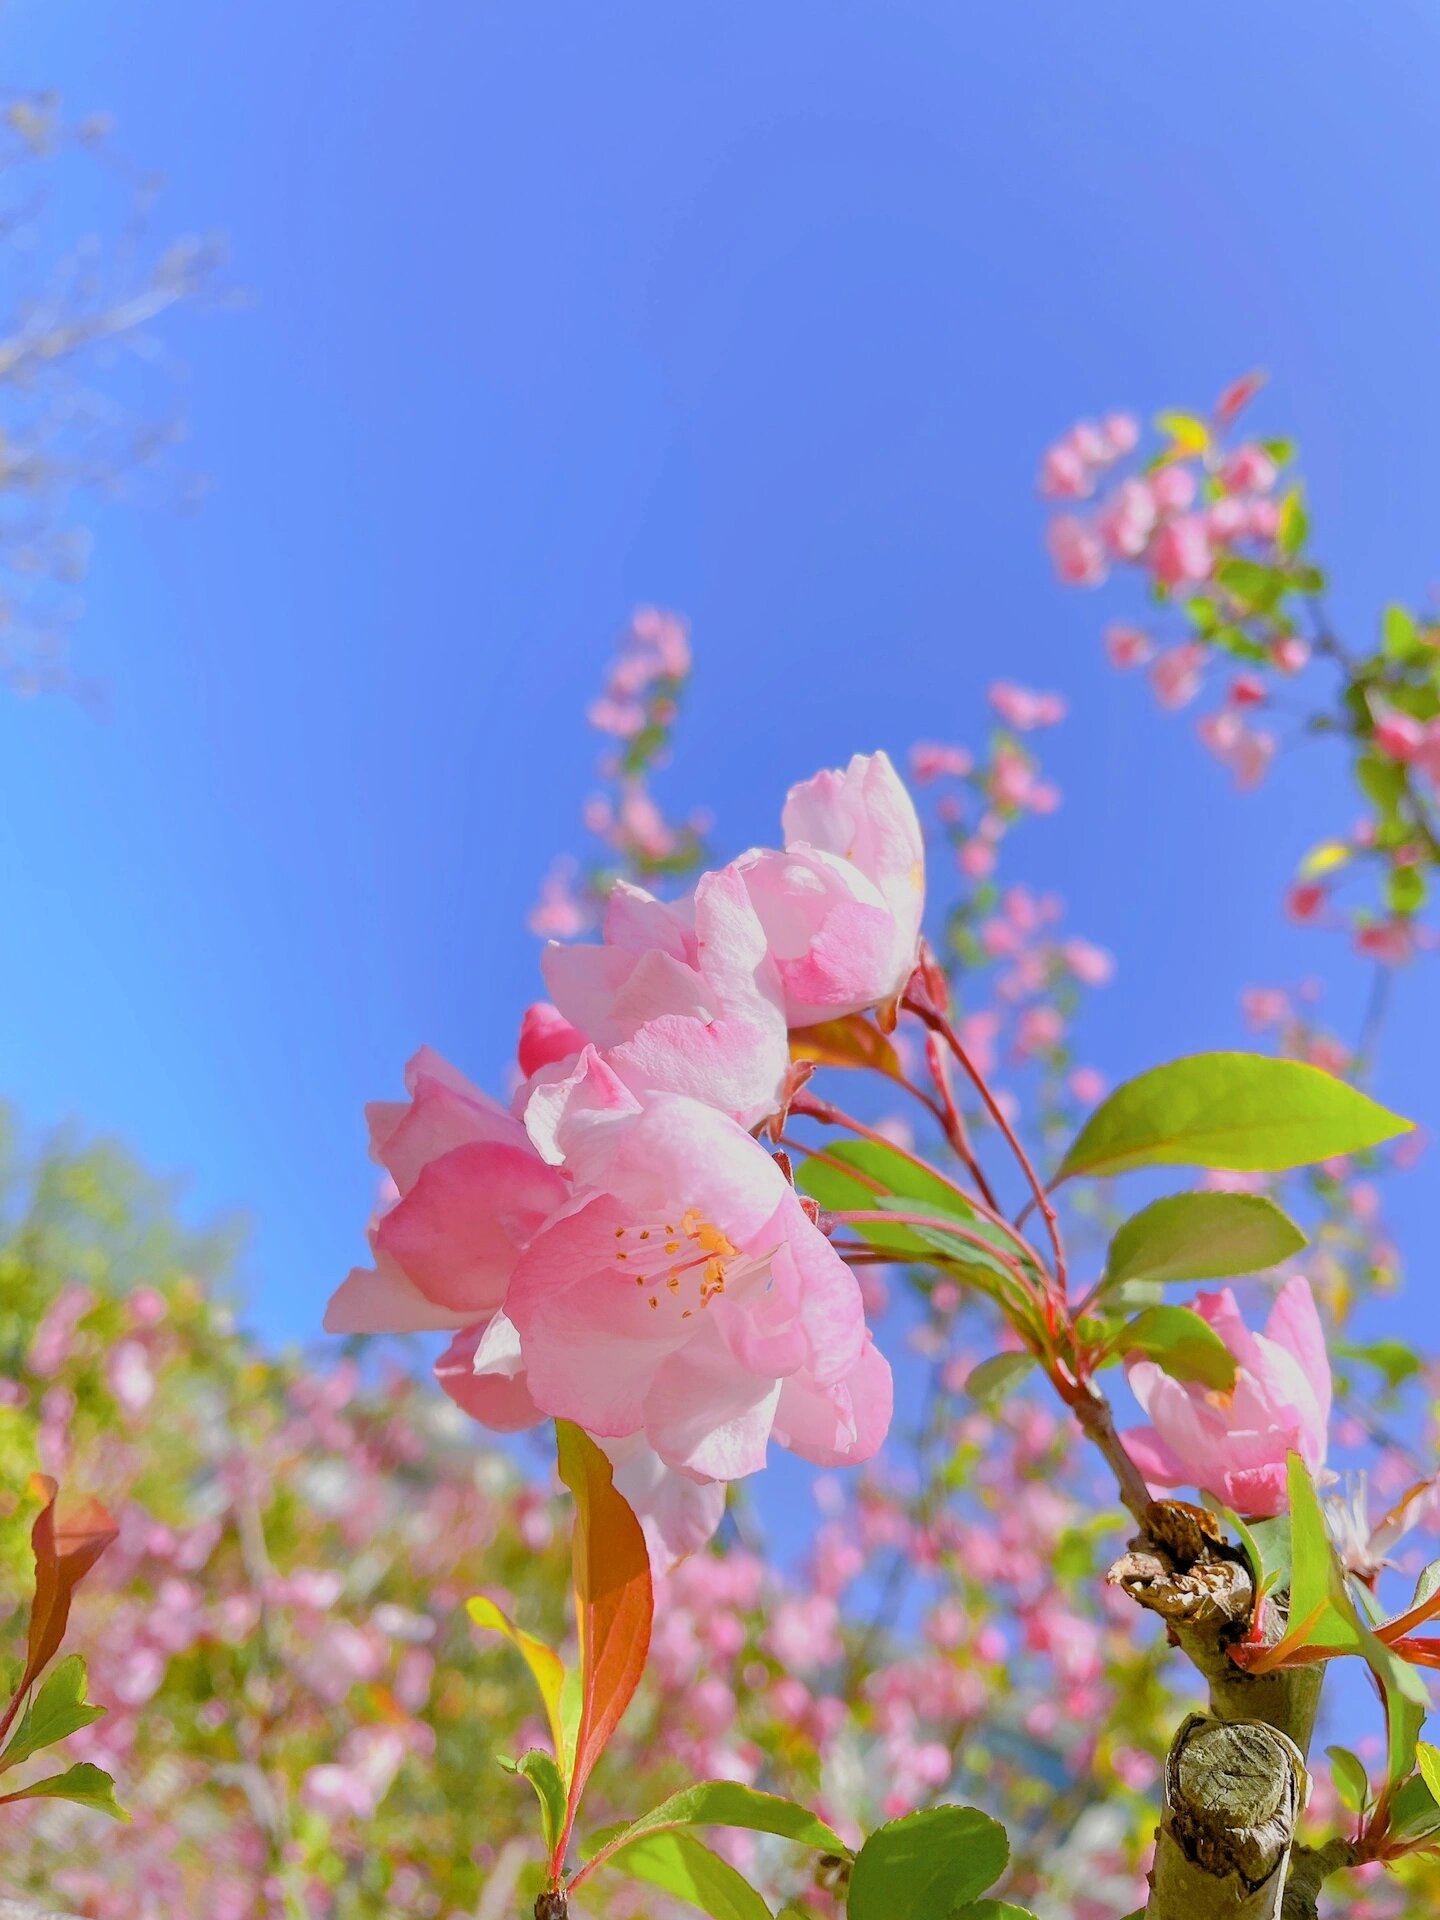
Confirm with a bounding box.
[847,1807,1010,1920]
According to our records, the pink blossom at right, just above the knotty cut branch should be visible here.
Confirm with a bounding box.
[1123,1275,1331,1519]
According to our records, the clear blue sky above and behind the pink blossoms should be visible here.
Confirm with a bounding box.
[0,0,1440,1367]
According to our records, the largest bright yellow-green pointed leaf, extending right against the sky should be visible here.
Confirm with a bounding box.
[1052,1054,1411,1185]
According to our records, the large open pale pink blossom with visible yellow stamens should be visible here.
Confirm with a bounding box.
[503,1048,891,1480]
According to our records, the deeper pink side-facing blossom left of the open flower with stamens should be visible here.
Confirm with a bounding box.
[324,1046,570,1332]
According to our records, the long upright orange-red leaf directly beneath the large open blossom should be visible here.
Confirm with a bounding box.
[551,1421,655,1876]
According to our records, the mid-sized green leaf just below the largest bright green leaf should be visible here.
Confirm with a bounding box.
[1106,1192,1306,1286]
